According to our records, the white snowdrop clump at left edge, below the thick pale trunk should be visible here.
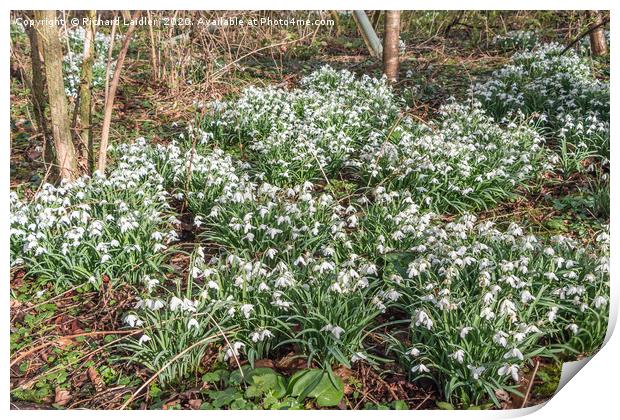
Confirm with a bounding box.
[10,140,178,288]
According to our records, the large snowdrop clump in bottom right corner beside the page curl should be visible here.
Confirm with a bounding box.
[388,215,609,406]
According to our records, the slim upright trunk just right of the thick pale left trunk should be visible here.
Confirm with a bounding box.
[78,10,97,173]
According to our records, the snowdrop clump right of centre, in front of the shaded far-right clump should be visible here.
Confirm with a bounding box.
[358,101,549,212]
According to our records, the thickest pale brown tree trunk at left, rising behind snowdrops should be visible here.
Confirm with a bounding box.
[35,10,78,181]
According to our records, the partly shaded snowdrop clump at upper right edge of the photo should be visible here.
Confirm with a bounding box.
[474,43,610,166]
